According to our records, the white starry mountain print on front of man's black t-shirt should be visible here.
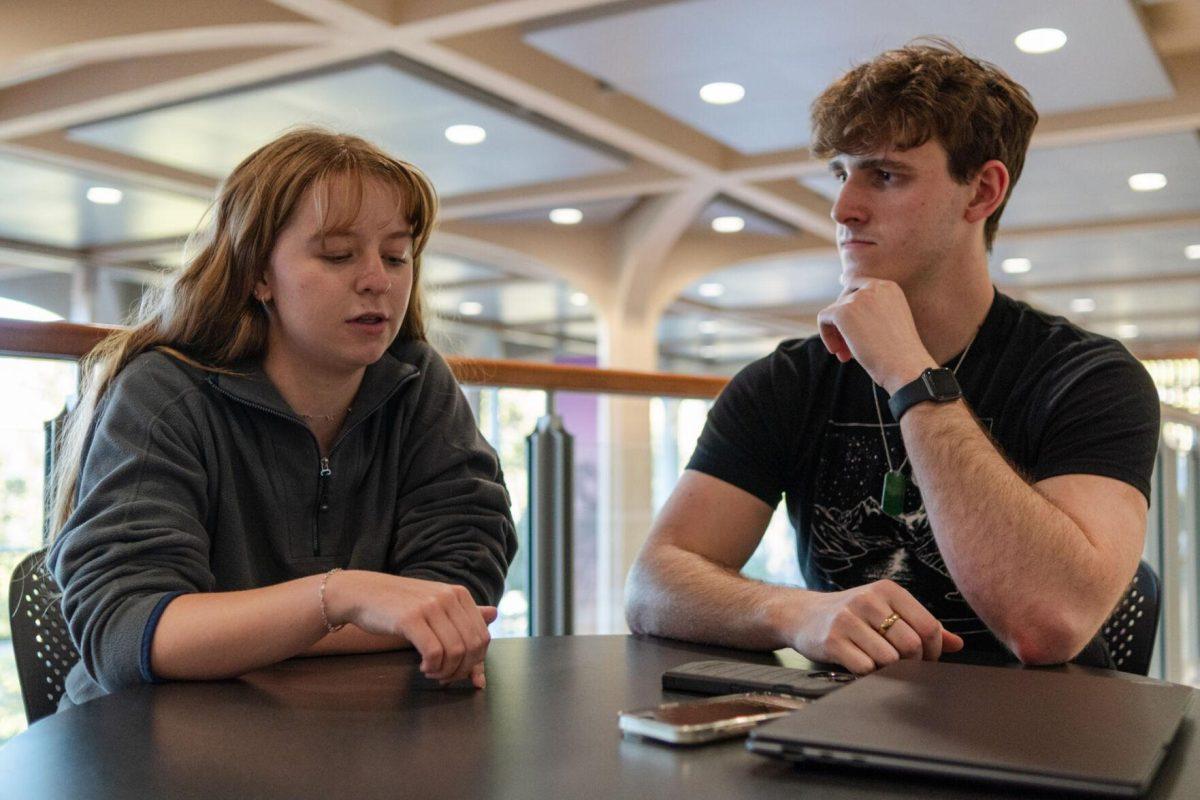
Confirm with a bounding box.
[805,420,991,634]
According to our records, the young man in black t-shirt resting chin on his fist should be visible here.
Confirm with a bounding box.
[626,43,1158,674]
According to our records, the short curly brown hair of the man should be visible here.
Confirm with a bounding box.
[811,38,1038,251]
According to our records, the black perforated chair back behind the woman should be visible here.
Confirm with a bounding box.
[8,548,79,724]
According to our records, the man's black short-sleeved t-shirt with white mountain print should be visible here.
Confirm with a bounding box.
[688,291,1159,663]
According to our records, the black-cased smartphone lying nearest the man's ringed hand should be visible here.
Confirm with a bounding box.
[662,661,854,698]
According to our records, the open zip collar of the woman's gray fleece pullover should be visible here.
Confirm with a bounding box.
[209,349,418,429]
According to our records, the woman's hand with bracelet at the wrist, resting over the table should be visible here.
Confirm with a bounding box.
[325,570,497,688]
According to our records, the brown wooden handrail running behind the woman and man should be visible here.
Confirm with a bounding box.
[0,319,728,399]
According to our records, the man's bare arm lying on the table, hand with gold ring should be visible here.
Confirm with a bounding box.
[625,471,962,673]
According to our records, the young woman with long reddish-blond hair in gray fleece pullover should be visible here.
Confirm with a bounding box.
[47,130,516,703]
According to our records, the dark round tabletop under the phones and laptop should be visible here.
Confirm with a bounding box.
[0,636,1200,800]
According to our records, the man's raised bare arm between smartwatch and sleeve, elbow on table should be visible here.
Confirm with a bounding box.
[901,401,1147,663]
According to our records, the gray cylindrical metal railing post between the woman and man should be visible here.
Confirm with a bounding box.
[526,392,575,636]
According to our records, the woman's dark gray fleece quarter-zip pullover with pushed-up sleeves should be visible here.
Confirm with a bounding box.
[47,342,516,703]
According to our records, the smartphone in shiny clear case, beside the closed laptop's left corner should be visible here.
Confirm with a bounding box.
[618,694,808,745]
